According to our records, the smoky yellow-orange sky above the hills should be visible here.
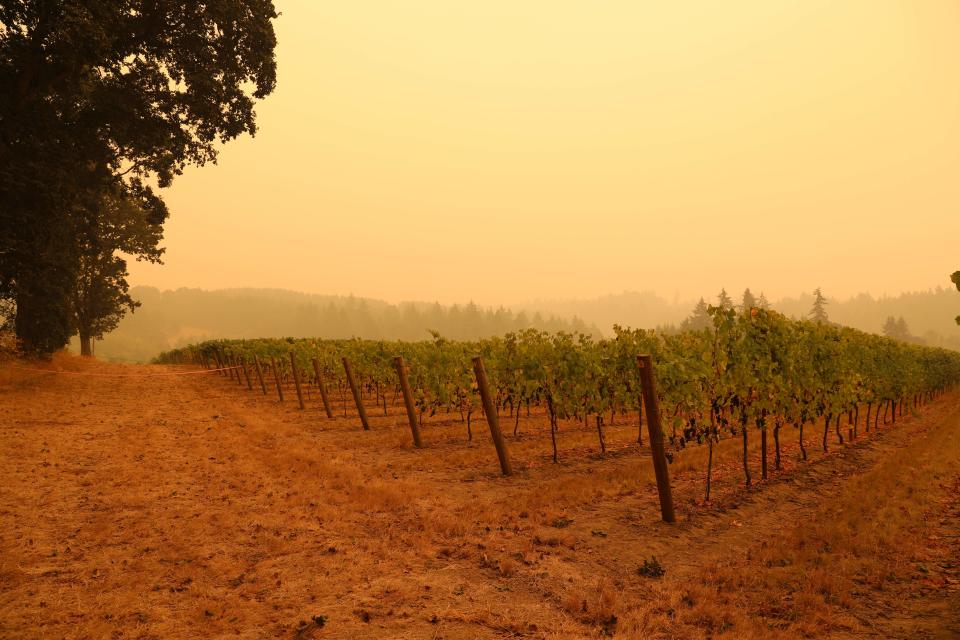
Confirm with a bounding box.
[131,0,960,304]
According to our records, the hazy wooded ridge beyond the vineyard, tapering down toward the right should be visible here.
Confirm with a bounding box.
[82,287,599,362]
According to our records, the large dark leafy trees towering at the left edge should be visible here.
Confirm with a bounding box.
[0,0,277,355]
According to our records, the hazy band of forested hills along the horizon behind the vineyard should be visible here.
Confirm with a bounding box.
[73,287,960,362]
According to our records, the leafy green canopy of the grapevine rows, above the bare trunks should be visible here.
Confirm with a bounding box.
[157,307,960,447]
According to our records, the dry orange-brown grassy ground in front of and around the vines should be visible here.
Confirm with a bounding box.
[0,356,960,640]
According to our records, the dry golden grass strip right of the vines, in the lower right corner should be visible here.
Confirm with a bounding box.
[621,396,960,638]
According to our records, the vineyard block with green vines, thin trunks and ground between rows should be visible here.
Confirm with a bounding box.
[158,307,960,499]
